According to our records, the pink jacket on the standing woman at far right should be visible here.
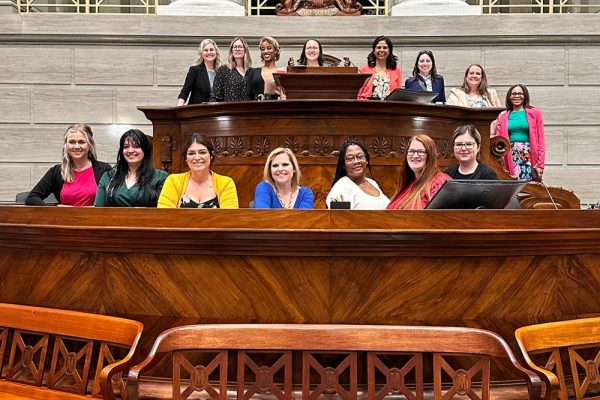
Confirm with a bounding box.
[496,107,546,176]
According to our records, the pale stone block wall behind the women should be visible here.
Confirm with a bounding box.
[0,14,600,203]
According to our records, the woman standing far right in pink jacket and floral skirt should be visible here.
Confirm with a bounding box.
[496,84,546,181]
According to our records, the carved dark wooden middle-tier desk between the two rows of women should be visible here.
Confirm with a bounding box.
[138,100,580,208]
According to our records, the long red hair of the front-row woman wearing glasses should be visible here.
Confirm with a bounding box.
[390,135,439,209]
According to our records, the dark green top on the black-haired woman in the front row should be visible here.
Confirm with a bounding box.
[94,168,169,207]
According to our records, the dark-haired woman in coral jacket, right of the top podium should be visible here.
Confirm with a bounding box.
[357,36,402,100]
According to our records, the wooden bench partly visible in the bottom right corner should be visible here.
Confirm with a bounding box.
[515,318,600,400]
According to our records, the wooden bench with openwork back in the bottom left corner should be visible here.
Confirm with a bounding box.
[0,303,143,400]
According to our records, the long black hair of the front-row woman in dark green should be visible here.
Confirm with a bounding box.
[106,129,159,206]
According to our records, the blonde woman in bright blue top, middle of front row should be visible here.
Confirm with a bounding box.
[254,147,314,208]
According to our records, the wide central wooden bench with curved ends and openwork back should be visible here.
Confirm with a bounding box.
[127,324,542,400]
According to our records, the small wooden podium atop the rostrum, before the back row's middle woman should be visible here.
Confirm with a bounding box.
[273,67,371,100]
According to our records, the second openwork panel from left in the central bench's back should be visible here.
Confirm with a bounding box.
[237,351,293,400]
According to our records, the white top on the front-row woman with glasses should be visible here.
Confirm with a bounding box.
[326,176,390,210]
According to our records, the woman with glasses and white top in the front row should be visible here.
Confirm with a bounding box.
[326,140,390,210]
